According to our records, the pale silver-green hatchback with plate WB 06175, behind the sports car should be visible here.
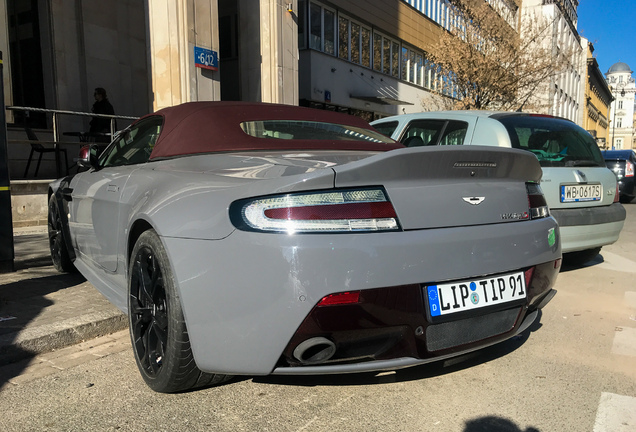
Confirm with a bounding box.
[371,111,626,264]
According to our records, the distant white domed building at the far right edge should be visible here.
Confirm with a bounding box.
[605,62,636,150]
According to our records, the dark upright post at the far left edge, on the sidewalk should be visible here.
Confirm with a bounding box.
[0,51,15,273]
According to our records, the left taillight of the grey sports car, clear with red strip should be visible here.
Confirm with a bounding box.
[235,189,400,234]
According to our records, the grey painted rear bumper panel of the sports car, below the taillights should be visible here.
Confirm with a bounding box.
[162,218,561,375]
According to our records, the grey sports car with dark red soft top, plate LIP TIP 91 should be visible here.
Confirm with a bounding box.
[49,102,561,392]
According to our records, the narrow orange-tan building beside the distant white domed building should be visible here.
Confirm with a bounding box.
[580,38,612,149]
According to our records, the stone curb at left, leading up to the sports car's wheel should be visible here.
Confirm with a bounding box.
[0,311,128,366]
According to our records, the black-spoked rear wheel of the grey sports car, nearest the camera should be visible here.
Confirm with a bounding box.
[128,230,230,393]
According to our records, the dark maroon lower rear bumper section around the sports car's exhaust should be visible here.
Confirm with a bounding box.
[276,262,560,374]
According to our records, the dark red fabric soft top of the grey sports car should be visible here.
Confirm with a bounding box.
[146,102,404,160]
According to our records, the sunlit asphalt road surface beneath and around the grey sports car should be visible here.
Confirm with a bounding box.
[0,204,636,432]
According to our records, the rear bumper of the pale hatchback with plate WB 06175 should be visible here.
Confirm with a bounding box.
[550,203,626,253]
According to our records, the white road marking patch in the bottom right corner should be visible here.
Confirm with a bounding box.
[594,393,636,432]
